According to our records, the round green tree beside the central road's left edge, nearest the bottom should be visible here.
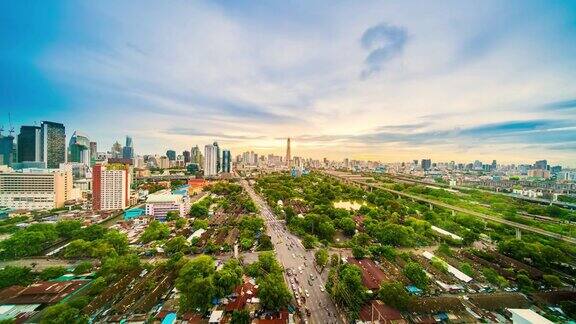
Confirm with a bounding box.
[258,273,292,311]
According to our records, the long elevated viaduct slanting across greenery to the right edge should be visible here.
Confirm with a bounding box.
[323,171,576,244]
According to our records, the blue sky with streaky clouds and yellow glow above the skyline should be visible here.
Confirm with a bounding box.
[0,0,576,167]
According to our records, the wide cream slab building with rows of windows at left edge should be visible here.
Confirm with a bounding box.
[0,169,72,210]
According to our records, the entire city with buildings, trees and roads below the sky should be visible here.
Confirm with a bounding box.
[0,121,576,324]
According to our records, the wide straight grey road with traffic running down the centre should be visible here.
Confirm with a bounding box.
[241,180,344,324]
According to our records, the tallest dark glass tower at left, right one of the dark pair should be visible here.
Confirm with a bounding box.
[40,121,66,169]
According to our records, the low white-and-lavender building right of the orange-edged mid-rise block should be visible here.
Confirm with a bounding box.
[146,190,190,220]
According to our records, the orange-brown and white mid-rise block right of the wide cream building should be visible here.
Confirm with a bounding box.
[92,163,132,210]
